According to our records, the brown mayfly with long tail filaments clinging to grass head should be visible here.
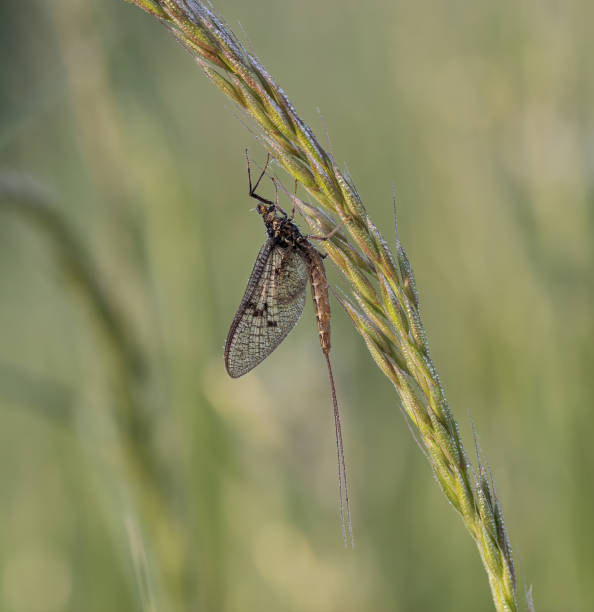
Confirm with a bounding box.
[225,151,353,545]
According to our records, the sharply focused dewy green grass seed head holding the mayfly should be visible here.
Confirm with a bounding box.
[128,0,517,611]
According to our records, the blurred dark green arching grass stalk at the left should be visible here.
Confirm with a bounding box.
[0,171,171,612]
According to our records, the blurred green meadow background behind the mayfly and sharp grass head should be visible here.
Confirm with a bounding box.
[0,0,594,612]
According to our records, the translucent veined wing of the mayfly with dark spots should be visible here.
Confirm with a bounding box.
[225,239,308,378]
